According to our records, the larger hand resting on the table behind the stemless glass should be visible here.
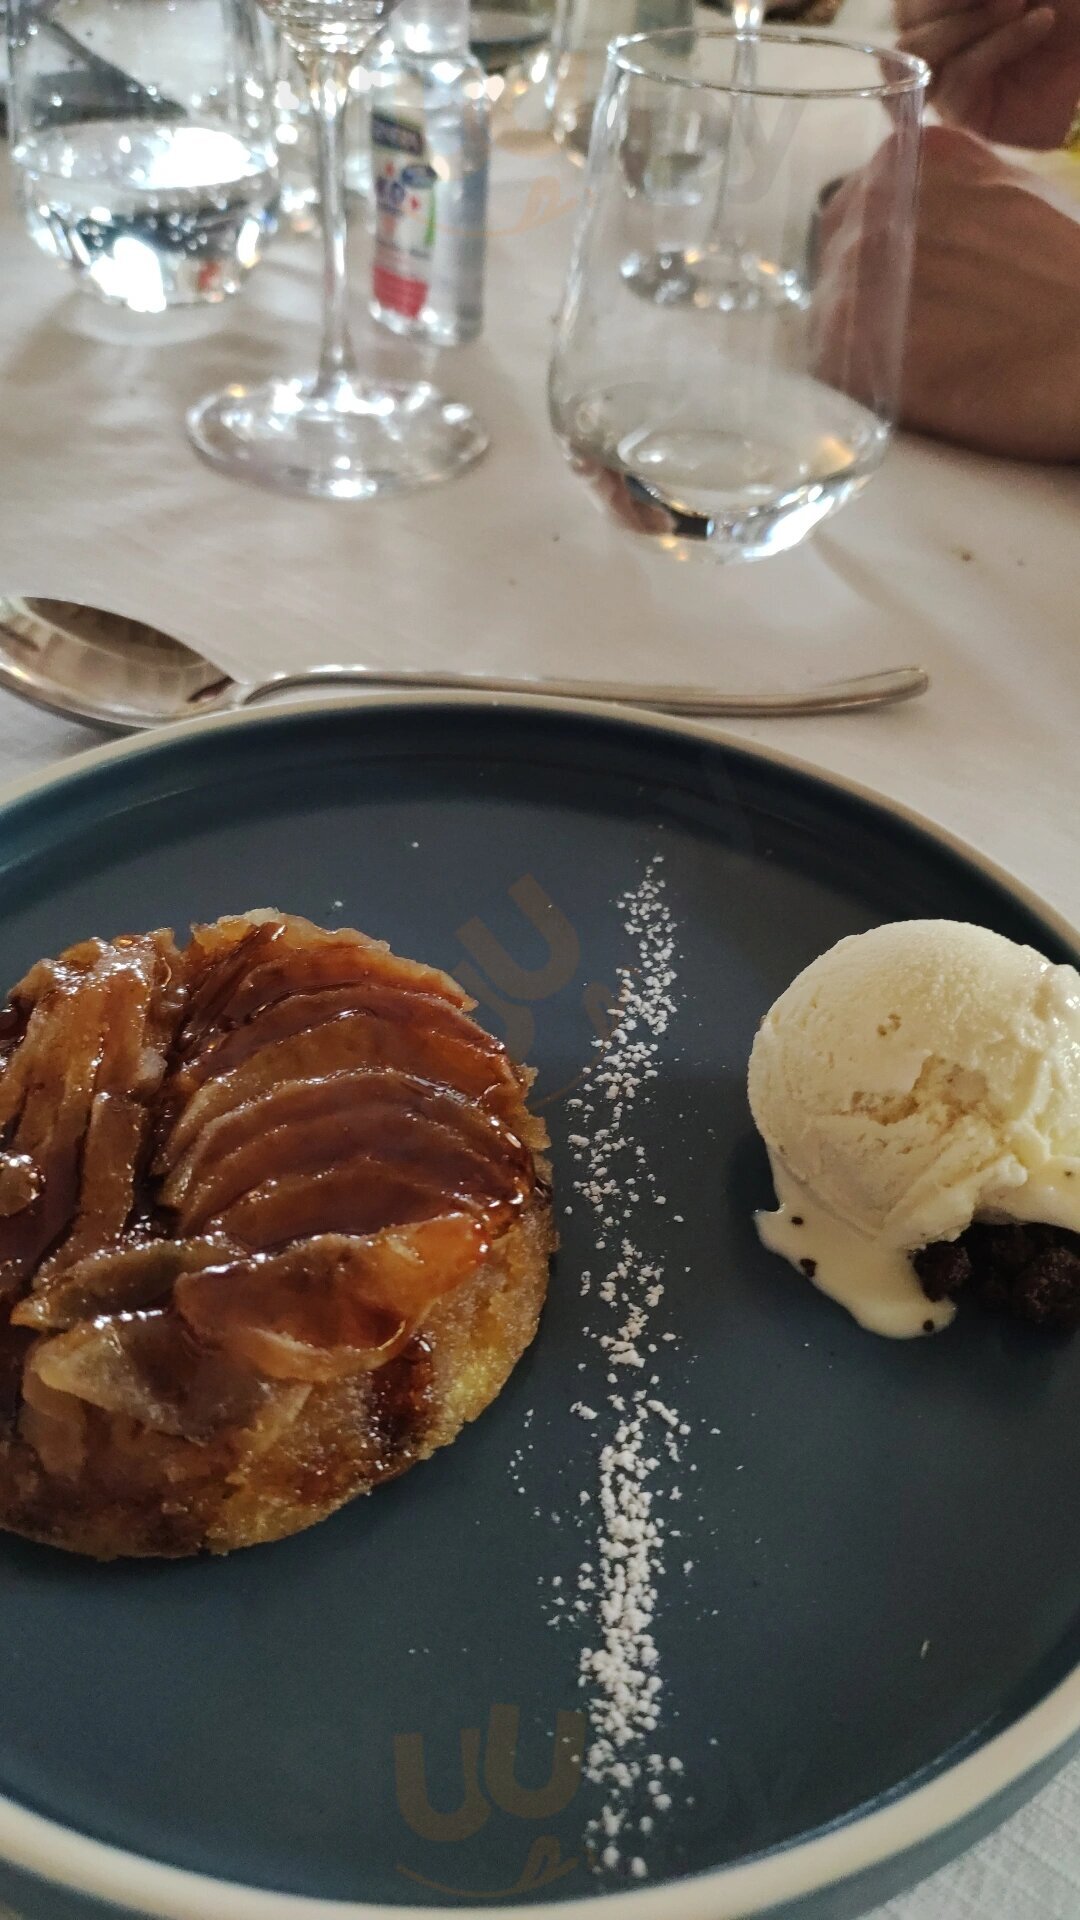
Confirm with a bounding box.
[815,127,1080,461]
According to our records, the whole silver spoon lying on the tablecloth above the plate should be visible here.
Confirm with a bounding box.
[0,599,930,732]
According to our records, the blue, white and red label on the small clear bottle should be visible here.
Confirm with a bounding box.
[371,113,436,321]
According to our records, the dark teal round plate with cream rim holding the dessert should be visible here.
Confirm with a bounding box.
[0,701,1080,1920]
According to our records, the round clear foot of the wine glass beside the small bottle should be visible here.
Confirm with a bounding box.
[188,374,488,499]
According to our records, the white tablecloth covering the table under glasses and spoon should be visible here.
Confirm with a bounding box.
[0,93,1080,1920]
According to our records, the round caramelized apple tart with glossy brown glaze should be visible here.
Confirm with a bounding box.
[0,912,553,1559]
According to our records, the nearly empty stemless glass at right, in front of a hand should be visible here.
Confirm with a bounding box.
[550,31,928,559]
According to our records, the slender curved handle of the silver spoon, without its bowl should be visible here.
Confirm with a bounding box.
[238,666,930,718]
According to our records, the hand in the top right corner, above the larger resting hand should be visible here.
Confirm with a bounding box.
[896,0,1080,148]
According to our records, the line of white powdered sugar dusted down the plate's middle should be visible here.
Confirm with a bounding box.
[553,854,690,1880]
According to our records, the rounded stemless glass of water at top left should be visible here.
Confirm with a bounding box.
[8,0,279,313]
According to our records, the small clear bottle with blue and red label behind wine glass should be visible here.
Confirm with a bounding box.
[369,0,490,346]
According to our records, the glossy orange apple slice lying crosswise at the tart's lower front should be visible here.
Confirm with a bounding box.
[175,1213,484,1382]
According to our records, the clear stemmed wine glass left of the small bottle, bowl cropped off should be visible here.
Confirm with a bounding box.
[188,0,488,499]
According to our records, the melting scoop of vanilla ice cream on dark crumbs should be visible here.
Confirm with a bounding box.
[749,920,1080,1336]
